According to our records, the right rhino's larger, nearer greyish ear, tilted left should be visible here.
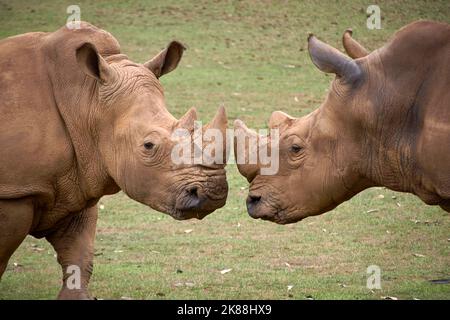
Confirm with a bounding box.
[308,34,362,83]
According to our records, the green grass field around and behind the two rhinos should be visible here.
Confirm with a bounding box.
[0,0,450,299]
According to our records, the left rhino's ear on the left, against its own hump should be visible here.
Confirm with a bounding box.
[76,42,113,82]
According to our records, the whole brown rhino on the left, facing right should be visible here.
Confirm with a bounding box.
[0,22,228,299]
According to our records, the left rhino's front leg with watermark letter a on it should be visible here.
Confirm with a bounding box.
[46,206,97,300]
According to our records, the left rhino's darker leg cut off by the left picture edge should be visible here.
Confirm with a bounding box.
[0,199,33,279]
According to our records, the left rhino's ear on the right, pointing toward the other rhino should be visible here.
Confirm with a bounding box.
[144,41,186,78]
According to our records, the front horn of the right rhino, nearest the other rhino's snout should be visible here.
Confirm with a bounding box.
[234,119,259,182]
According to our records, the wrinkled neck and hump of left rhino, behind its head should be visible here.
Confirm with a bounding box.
[42,25,120,201]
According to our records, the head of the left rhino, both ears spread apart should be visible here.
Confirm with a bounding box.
[76,42,228,220]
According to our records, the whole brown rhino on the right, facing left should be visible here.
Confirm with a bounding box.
[235,21,450,224]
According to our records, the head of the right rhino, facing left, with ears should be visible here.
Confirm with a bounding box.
[235,31,373,224]
